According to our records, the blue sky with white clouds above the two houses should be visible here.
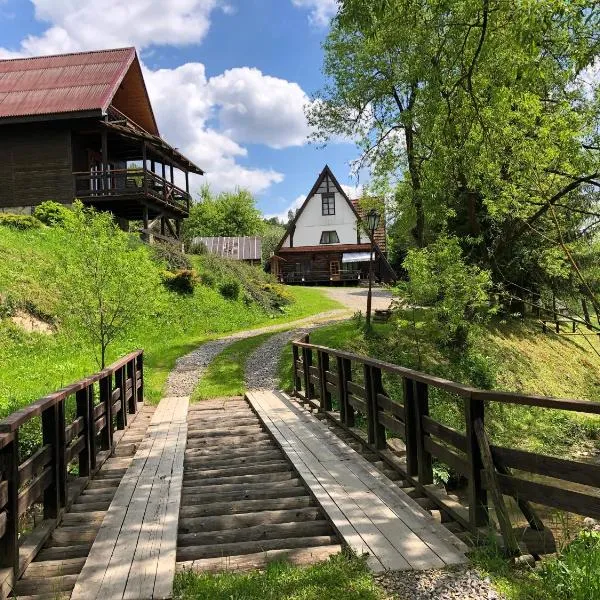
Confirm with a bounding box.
[0,0,357,220]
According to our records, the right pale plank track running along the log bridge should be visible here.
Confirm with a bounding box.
[247,391,466,572]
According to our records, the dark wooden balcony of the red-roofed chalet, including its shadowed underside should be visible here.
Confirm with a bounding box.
[73,168,191,218]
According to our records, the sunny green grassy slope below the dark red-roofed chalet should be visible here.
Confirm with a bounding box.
[0,220,339,416]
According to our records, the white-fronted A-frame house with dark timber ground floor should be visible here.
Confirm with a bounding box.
[271,165,396,284]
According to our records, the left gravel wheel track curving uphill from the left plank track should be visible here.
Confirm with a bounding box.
[165,310,350,396]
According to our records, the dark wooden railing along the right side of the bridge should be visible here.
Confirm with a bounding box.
[292,336,600,553]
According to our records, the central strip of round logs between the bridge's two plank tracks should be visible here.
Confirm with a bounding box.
[177,398,341,572]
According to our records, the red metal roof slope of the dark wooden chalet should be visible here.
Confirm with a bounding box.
[0,48,136,119]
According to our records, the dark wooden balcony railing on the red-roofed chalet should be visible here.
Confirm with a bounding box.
[73,169,191,213]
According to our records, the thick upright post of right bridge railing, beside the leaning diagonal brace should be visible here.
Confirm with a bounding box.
[464,396,488,534]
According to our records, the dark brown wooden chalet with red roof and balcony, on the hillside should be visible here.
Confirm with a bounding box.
[0,48,203,238]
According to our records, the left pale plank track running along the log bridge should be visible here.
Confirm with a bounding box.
[71,397,188,600]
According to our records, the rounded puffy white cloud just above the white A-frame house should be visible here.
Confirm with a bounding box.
[209,67,310,148]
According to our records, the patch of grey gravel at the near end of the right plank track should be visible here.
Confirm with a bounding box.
[375,568,504,600]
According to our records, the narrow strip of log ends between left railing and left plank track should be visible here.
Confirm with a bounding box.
[14,405,155,600]
